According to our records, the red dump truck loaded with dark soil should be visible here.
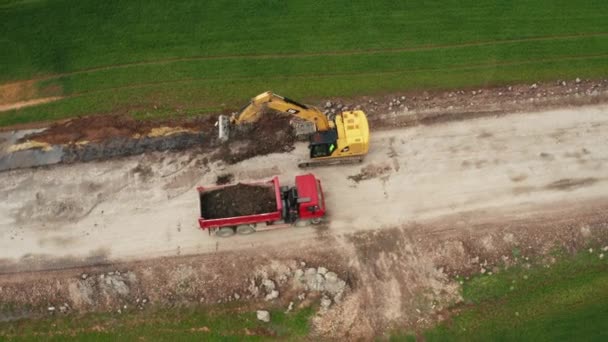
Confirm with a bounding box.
[197,174,325,237]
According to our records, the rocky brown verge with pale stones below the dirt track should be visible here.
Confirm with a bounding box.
[0,201,608,339]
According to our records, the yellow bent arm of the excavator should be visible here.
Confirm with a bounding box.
[232,91,334,132]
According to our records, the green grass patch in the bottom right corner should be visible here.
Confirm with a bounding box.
[404,250,608,342]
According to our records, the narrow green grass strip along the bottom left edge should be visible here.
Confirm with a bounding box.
[0,305,315,341]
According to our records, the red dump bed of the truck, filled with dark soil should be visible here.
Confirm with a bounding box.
[198,177,283,229]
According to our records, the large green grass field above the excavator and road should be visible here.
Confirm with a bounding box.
[0,0,608,126]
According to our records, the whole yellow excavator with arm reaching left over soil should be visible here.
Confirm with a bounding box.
[219,91,369,167]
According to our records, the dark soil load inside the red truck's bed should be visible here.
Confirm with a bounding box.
[200,183,277,219]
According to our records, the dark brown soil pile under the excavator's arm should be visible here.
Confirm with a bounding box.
[217,112,296,164]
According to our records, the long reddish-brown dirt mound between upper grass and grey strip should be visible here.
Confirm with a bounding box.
[21,115,215,144]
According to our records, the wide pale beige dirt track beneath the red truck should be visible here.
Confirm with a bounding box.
[0,105,608,272]
